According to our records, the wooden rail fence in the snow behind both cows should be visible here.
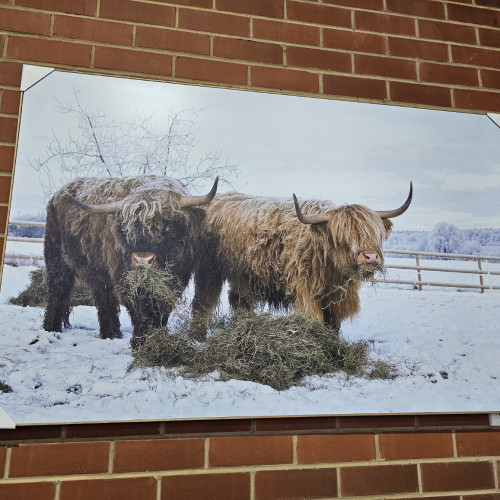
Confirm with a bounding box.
[5,221,500,293]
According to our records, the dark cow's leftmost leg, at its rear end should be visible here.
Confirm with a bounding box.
[43,262,75,332]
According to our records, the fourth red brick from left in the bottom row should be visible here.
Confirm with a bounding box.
[255,469,337,500]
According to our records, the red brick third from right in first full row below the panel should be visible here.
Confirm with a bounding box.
[297,434,375,464]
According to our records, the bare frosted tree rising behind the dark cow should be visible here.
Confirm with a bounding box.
[29,89,238,199]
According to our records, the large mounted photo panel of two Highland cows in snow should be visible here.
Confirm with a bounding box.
[0,68,500,423]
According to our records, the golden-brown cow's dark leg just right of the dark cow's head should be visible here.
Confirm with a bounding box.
[190,261,224,340]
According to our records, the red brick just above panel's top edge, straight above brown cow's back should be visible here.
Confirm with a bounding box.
[251,66,319,93]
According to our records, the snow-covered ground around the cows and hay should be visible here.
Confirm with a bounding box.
[0,259,500,423]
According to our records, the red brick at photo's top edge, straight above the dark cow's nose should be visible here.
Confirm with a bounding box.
[99,0,175,26]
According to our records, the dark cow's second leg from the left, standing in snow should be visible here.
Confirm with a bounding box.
[88,275,122,339]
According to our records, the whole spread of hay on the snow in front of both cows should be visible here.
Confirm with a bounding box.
[129,312,394,391]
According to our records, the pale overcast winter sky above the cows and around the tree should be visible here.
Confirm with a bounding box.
[11,68,500,230]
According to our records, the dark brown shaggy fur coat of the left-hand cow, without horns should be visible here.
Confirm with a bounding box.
[43,175,206,348]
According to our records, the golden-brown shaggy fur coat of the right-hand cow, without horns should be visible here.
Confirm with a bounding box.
[193,193,392,337]
